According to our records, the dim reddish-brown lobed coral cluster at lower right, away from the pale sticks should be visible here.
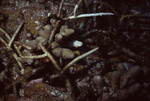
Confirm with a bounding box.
[77,64,142,101]
